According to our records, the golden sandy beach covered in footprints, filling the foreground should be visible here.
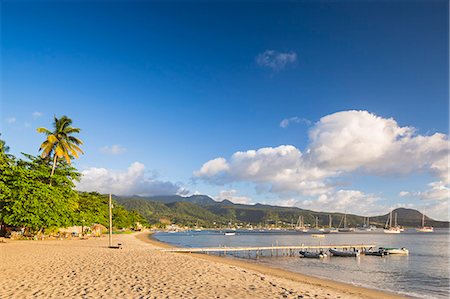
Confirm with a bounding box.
[0,233,406,299]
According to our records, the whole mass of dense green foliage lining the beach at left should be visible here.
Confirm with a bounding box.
[0,136,146,235]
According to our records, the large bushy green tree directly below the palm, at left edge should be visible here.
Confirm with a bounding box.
[0,155,79,237]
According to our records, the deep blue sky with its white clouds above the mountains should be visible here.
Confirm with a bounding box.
[0,1,449,218]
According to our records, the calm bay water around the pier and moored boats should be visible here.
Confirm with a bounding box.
[155,229,450,298]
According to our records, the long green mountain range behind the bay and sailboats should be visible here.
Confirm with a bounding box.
[115,195,449,227]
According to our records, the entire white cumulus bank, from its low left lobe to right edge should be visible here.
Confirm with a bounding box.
[194,111,449,218]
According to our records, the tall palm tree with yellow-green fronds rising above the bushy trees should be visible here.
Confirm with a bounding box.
[37,115,83,177]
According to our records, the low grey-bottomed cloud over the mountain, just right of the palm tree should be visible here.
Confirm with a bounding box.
[76,162,187,196]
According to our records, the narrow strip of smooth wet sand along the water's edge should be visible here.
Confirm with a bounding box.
[144,232,411,299]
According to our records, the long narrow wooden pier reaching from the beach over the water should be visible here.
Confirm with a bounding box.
[161,244,376,258]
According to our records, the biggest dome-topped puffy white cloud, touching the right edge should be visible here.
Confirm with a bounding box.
[308,111,449,179]
